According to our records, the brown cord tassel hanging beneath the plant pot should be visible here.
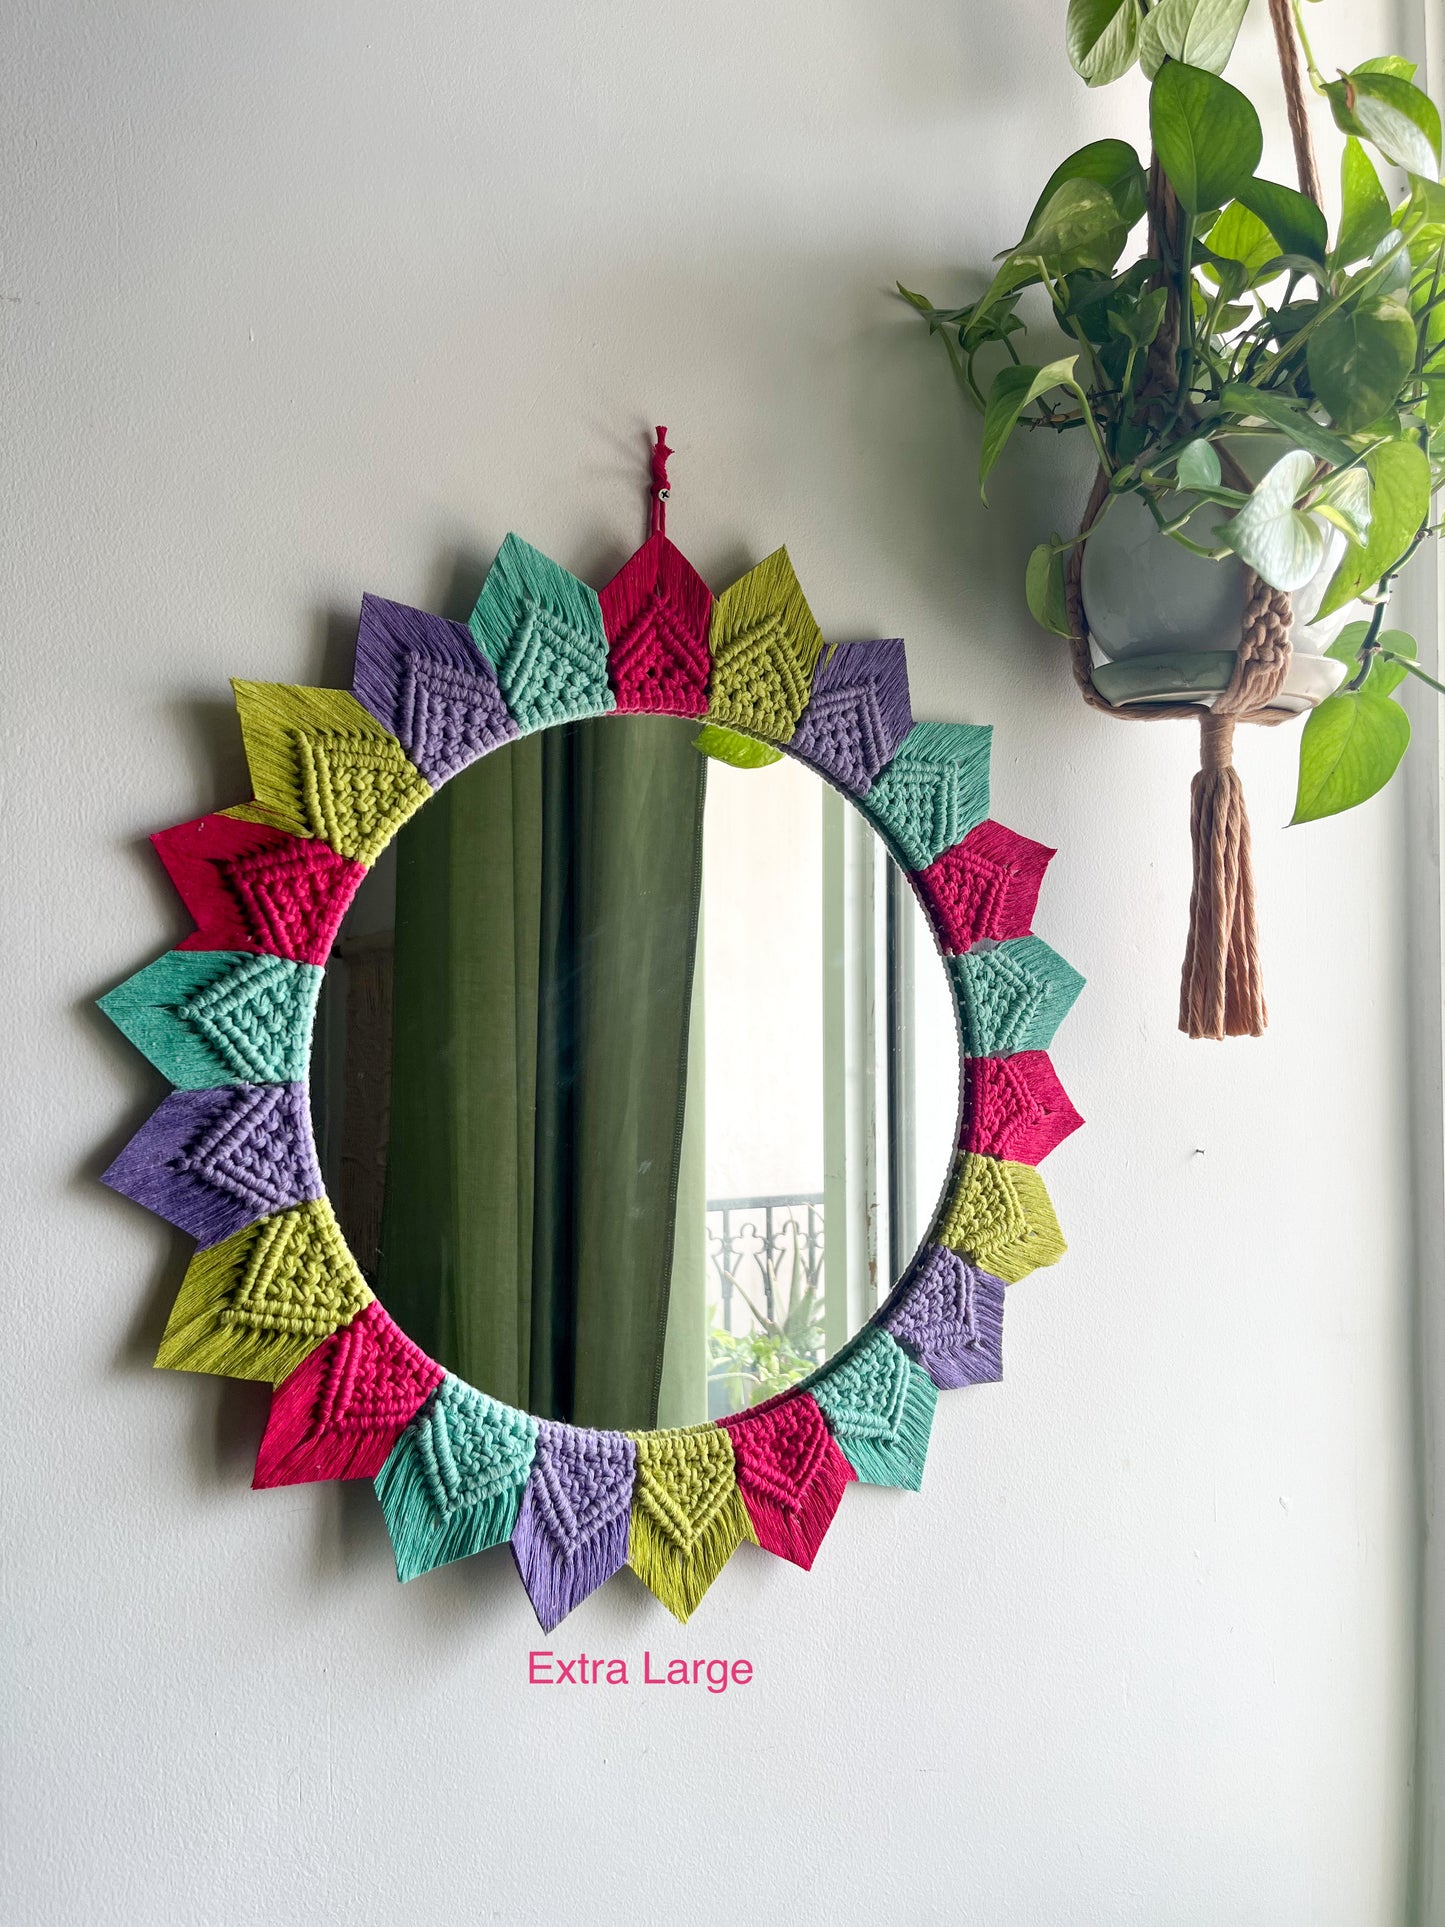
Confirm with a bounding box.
[1179,715,1270,1039]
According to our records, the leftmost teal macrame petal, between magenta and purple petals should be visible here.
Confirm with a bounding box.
[100,950,322,1091]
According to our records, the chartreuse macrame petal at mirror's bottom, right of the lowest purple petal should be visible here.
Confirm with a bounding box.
[628,1426,757,1621]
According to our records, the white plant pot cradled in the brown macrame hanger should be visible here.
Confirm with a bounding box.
[1079,495,1364,709]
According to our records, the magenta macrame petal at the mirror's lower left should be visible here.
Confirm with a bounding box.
[252,1299,443,1486]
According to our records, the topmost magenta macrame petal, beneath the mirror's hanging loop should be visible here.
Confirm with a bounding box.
[597,536,713,717]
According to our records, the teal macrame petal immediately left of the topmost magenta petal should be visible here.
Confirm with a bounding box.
[470,536,617,730]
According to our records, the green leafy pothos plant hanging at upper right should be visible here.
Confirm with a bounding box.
[900,0,1445,823]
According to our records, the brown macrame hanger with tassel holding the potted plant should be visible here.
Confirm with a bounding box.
[1065,0,1320,1039]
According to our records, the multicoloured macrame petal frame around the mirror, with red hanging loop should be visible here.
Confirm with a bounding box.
[100,443,1083,1630]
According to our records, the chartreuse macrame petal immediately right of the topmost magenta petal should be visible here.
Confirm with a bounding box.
[707,549,823,742]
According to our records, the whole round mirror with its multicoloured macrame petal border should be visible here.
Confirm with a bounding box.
[102,524,1081,1628]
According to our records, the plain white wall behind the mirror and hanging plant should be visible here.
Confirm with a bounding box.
[0,0,1416,1927]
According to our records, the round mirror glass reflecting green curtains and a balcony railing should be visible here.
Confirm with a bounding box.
[312,717,959,1430]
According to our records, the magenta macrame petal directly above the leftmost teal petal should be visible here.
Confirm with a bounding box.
[150,815,366,964]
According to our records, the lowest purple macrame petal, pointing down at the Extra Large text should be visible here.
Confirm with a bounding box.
[512,1422,638,1632]
